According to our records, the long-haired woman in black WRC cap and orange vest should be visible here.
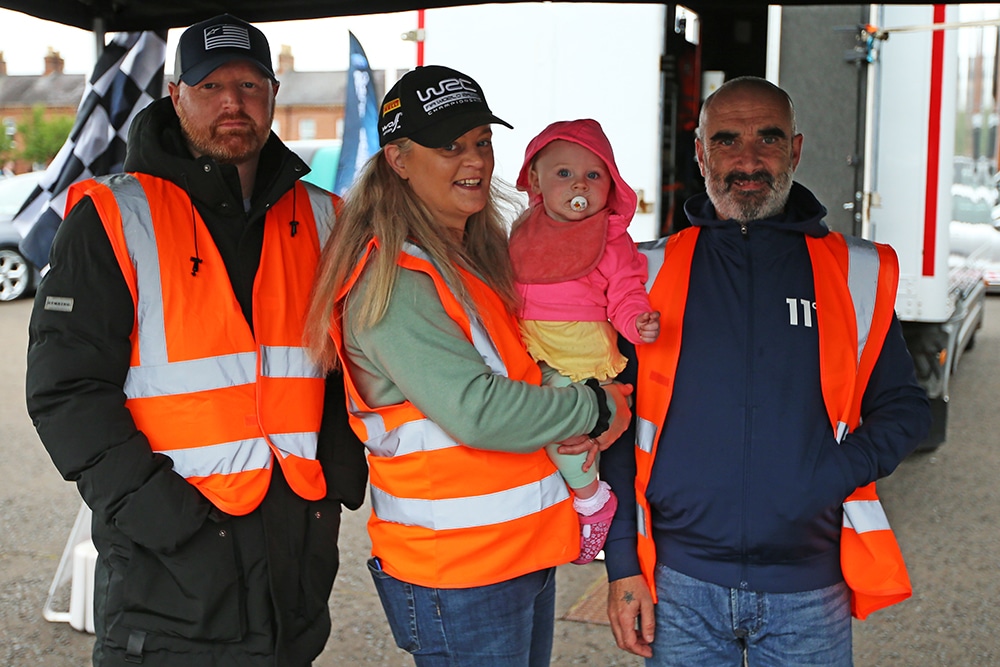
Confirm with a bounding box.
[308,66,631,667]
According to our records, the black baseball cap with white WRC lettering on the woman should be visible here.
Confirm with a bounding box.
[378,65,514,148]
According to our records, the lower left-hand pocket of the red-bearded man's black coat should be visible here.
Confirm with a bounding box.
[122,522,246,642]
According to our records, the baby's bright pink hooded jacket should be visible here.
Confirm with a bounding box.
[515,119,652,343]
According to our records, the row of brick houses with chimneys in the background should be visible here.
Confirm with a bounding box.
[0,45,385,173]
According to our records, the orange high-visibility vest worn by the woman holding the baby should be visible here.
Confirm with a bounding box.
[331,241,580,588]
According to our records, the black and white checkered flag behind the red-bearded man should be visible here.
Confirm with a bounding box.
[14,31,167,267]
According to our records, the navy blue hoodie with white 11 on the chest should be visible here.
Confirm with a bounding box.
[601,184,930,593]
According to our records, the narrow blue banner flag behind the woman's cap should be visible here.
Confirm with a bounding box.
[333,33,379,195]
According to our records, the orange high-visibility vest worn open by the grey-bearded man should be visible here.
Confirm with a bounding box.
[635,227,912,619]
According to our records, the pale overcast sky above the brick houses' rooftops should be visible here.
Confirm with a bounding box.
[0,8,417,76]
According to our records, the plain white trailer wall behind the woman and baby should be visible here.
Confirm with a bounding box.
[424,2,666,241]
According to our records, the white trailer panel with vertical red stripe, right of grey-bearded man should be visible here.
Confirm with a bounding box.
[867,5,958,322]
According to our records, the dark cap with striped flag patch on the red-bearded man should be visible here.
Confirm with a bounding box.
[174,14,277,86]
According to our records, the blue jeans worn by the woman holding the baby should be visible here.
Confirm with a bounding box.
[368,558,556,667]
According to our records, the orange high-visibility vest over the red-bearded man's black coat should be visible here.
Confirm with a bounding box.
[67,174,334,515]
